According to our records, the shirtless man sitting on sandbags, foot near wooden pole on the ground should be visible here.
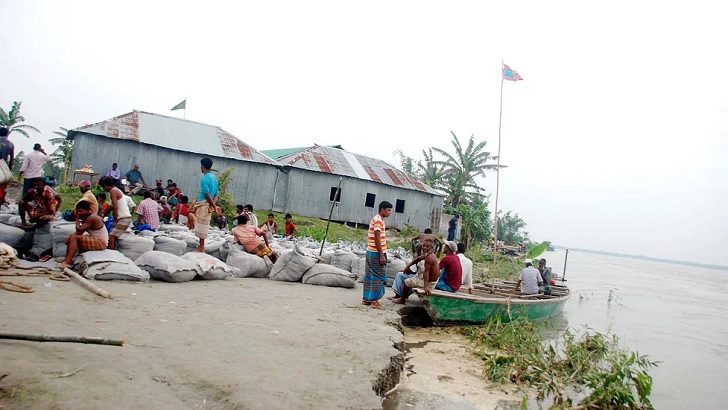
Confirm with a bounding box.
[58,201,108,268]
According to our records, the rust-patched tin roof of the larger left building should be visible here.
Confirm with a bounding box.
[68,110,278,165]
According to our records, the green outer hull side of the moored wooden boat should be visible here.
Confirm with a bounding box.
[417,289,569,325]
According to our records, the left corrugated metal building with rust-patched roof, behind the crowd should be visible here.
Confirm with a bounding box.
[68,111,284,209]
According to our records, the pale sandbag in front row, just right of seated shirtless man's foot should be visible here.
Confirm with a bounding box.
[74,249,149,282]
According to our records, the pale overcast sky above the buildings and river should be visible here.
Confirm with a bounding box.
[0,0,728,265]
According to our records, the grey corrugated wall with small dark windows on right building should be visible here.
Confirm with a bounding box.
[287,168,442,230]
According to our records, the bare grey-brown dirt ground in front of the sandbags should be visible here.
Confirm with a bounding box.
[0,270,403,409]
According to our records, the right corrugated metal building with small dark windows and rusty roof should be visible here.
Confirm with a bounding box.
[276,145,444,230]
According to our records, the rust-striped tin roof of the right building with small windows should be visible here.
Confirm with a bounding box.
[278,145,442,195]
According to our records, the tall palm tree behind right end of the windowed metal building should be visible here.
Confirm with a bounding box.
[432,131,504,208]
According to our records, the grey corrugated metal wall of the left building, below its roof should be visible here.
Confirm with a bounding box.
[71,133,282,209]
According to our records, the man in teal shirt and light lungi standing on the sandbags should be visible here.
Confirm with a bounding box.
[187,157,222,252]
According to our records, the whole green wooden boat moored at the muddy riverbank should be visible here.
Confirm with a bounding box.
[414,282,569,326]
